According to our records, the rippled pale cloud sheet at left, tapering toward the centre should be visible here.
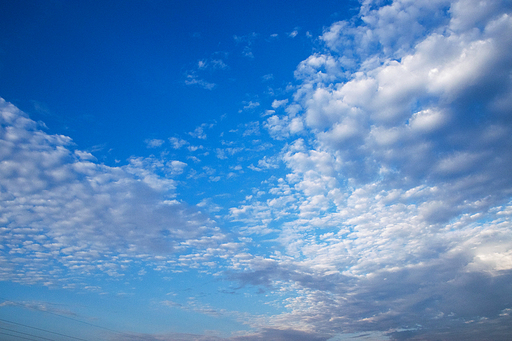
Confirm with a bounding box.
[0,100,223,286]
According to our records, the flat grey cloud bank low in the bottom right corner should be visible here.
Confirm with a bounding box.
[226,252,512,340]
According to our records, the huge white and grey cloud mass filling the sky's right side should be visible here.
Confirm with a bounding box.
[231,0,512,340]
